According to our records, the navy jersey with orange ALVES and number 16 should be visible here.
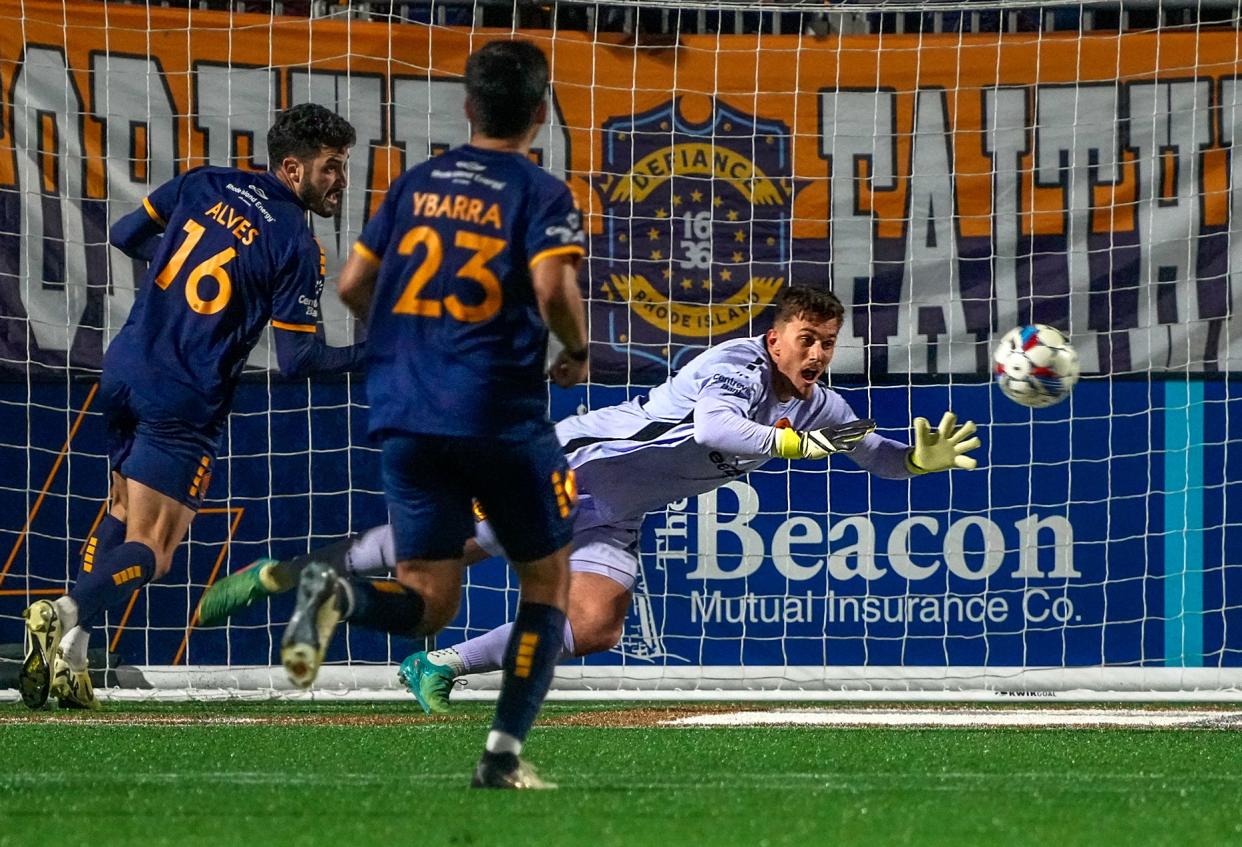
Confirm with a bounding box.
[104,166,323,424]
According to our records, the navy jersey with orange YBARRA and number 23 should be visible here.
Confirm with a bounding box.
[354,144,585,435]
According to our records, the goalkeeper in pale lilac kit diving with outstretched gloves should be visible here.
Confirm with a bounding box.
[199,286,980,713]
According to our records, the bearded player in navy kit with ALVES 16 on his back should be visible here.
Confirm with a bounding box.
[20,103,365,708]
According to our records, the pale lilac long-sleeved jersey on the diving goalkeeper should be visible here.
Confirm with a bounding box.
[556,335,910,523]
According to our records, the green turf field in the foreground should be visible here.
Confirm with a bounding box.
[0,703,1242,847]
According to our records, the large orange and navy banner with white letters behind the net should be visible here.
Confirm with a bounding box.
[0,0,1242,384]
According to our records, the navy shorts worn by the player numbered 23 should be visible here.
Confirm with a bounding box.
[383,426,578,563]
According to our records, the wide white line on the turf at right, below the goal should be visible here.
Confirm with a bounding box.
[661,709,1242,729]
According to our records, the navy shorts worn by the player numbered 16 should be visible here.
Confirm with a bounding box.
[99,374,224,512]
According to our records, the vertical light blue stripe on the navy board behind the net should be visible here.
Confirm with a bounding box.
[1164,380,1203,667]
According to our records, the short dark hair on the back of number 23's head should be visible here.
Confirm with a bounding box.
[466,40,548,138]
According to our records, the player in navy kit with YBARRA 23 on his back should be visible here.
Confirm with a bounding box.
[281,41,587,789]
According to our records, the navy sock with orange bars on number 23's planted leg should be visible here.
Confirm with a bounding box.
[487,602,565,755]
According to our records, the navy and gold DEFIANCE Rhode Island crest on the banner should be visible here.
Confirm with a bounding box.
[596,98,792,352]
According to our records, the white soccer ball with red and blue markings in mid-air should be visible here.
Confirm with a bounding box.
[992,323,1078,409]
